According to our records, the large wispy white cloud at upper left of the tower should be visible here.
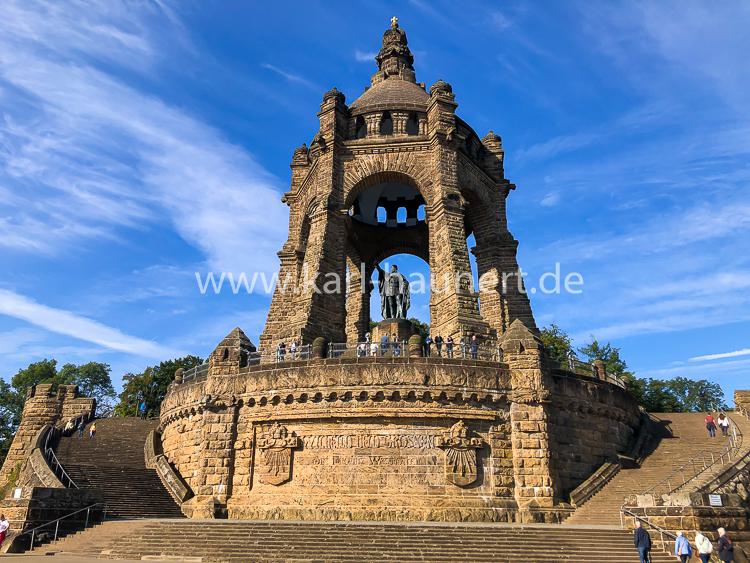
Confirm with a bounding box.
[0,2,287,278]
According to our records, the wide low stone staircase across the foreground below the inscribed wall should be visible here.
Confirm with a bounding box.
[39,520,674,563]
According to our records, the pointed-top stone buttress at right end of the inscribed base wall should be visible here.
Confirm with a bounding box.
[500,320,555,522]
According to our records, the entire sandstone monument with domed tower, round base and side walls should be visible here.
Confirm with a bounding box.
[0,18,750,563]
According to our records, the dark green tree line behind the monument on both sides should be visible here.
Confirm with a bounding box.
[0,319,727,459]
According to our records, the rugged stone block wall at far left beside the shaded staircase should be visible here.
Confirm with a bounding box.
[0,383,96,490]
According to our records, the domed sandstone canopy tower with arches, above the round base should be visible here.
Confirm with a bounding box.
[260,18,535,351]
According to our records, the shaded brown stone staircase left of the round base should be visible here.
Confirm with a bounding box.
[55,418,182,518]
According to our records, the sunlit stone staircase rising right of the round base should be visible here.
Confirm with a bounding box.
[565,413,750,526]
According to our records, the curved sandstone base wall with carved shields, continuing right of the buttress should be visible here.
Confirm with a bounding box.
[161,358,638,521]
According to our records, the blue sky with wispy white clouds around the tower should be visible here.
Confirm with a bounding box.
[0,0,750,404]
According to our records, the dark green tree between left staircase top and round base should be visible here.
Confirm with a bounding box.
[115,356,203,416]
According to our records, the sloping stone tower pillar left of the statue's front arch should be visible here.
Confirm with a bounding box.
[260,88,349,354]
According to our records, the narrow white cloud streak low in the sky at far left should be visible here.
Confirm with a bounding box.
[0,289,184,358]
